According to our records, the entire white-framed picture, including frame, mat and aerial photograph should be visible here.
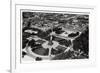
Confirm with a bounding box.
[10,0,96,73]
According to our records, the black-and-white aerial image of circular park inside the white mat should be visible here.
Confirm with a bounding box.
[20,10,89,62]
